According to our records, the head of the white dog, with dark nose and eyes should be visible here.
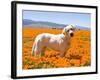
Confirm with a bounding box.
[62,25,75,37]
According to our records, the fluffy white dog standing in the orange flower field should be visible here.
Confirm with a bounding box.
[32,25,75,57]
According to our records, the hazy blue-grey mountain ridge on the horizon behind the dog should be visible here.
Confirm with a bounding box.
[23,19,90,30]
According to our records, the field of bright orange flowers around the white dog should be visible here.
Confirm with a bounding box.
[22,27,91,69]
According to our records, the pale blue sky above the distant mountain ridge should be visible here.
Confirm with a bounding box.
[23,10,91,28]
